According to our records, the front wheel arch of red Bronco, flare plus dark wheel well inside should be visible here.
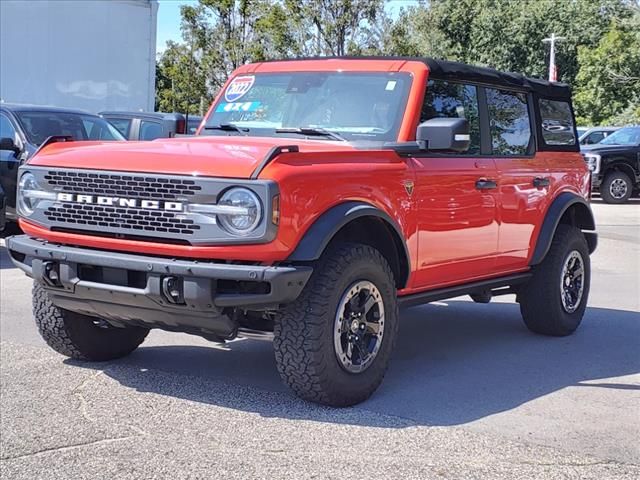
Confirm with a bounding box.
[287,201,411,288]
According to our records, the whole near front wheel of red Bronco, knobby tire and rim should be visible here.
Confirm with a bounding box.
[274,243,399,407]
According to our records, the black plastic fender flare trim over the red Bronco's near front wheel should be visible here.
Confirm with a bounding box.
[287,201,411,285]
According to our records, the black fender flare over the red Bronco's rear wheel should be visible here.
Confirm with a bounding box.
[529,192,598,266]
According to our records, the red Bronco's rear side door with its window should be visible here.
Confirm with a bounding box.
[485,87,562,272]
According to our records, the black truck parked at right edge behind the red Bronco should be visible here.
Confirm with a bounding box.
[581,126,640,203]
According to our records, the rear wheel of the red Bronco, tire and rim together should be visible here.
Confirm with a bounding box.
[518,225,591,337]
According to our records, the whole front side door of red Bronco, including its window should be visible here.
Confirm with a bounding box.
[413,80,498,289]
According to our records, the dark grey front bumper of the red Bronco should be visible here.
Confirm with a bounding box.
[7,235,313,339]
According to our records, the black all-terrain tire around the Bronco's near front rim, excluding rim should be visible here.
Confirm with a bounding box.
[274,243,399,407]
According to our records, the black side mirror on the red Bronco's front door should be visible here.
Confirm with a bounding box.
[416,118,471,152]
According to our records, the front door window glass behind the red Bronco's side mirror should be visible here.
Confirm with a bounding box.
[420,80,480,155]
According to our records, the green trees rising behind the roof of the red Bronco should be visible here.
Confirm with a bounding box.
[157,0,640,124]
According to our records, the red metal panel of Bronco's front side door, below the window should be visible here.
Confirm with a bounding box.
[413,156,498,289]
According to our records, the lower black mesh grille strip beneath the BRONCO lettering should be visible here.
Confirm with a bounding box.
[44,203,200,235]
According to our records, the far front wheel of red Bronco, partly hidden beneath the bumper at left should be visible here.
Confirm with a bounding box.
[33,283,149,362]
